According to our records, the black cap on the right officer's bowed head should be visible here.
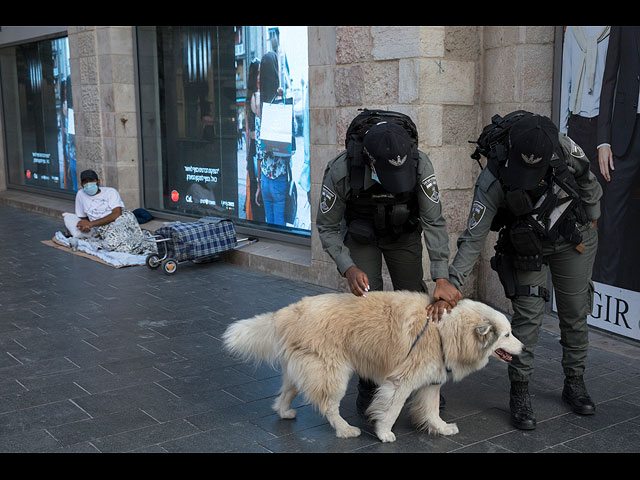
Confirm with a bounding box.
[500,115,558,190]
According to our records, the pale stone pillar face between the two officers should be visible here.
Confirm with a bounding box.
[417,26,481,297]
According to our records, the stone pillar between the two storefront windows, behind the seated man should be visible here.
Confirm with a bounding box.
[68,26,141,210]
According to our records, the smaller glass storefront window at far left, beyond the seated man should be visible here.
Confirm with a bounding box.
[0,37,78,194]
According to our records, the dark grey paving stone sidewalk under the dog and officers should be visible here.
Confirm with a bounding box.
[0,206,640,453]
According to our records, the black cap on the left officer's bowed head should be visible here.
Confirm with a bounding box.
[362,122,416,193]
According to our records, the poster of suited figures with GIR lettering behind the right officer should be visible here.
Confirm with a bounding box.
[558,26,640,340]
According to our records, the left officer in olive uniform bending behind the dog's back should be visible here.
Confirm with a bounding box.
[316,112,461,413]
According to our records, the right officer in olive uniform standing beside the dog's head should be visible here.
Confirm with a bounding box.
[449,114,602,430]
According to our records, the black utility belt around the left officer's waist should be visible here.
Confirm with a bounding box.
[346,203,420,245]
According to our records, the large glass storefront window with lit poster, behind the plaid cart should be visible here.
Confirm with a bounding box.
[136,26,311,236]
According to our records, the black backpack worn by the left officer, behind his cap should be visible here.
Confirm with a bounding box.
[345,108,418,196]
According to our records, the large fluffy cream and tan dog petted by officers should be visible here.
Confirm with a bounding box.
[223,291,523,442]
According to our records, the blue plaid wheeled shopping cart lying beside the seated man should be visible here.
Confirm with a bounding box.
[146,217,257,275]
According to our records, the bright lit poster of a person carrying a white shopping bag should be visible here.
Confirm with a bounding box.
[238,26,311,231]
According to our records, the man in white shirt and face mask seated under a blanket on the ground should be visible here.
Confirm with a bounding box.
[63,170,156,255]
